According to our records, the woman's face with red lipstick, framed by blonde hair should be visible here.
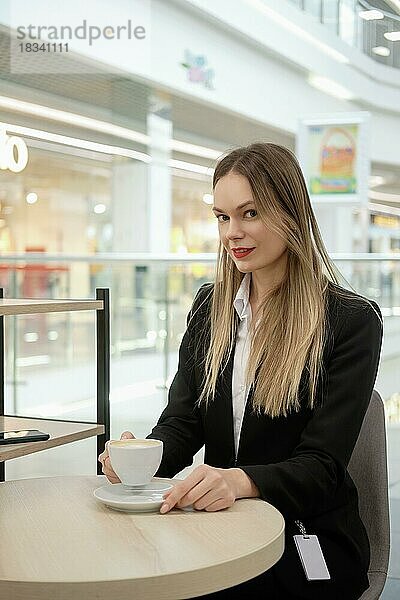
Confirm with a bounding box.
[212,173,287,276]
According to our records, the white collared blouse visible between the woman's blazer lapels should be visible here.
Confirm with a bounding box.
[232,273,252,457]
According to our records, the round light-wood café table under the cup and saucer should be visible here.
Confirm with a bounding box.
[0,476,285,600]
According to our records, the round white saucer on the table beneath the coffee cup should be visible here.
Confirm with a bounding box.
[93,478,173,512]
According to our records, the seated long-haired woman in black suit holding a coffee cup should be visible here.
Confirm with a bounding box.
[100,143,382,600]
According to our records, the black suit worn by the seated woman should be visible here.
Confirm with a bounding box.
[148,284,382,600]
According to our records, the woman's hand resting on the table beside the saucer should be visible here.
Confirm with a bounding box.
[160,465,259,513]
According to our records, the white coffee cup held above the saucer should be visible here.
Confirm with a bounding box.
[108,439,163,486]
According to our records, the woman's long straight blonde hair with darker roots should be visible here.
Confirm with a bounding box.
[198,143,346,417]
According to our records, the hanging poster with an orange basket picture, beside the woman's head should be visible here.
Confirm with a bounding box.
[307,124,359,195]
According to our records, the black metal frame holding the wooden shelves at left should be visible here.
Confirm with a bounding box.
[0,288,110,481]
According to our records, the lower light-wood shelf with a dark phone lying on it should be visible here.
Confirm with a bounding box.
[0,416,104,462]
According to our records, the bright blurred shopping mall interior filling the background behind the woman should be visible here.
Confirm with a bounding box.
[0,0,400,598]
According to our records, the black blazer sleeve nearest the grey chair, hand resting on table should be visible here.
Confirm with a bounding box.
[238,302,382,519]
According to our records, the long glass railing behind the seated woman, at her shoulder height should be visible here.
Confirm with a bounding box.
[0,254,400,434]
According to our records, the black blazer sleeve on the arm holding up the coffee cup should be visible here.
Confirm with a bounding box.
[147,284,209,477]
